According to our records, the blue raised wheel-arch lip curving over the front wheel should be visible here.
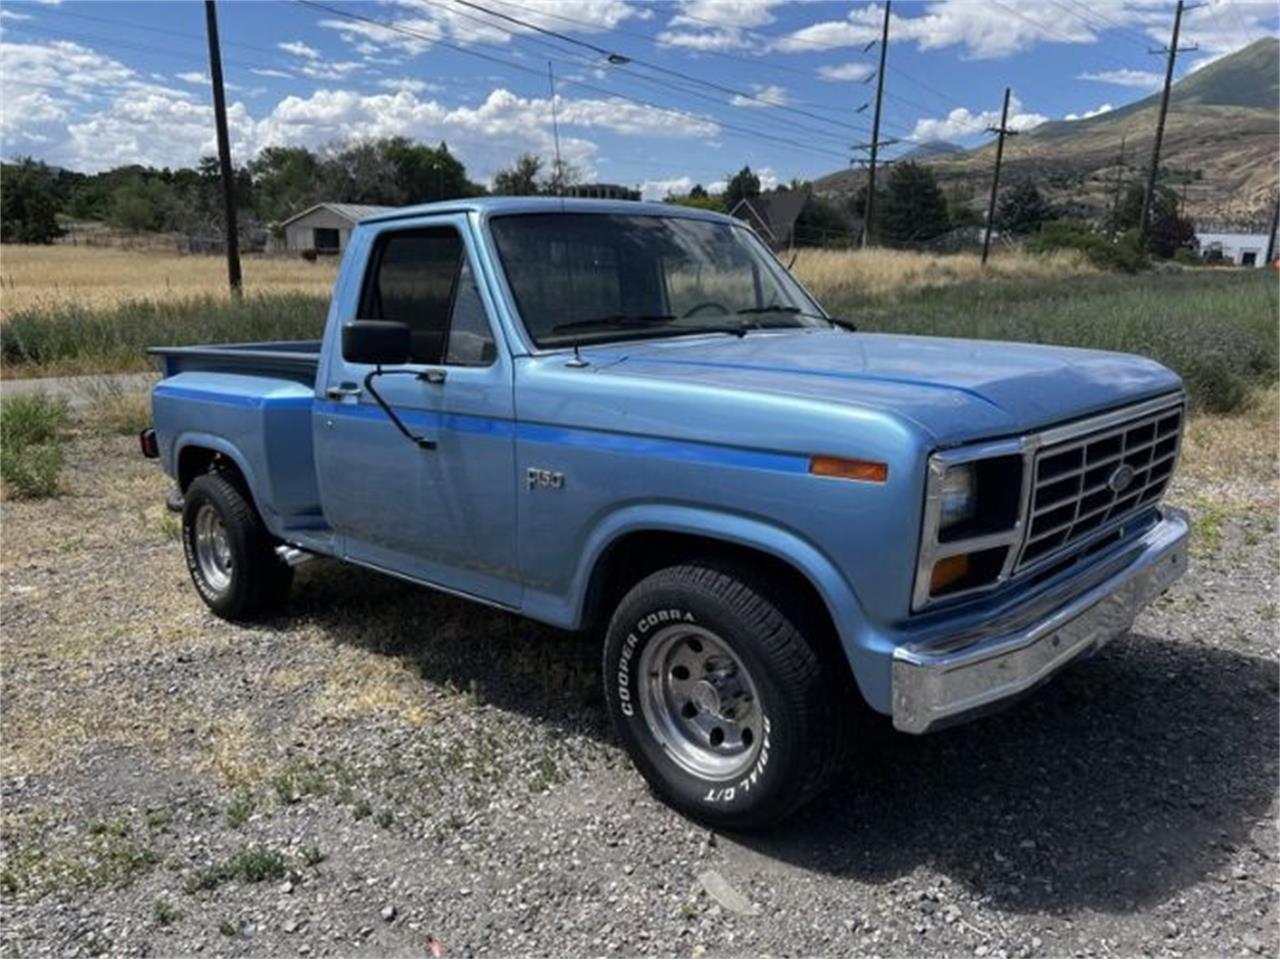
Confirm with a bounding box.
[525,504,893,712]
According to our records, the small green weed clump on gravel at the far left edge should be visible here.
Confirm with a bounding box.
[0,393,67,499]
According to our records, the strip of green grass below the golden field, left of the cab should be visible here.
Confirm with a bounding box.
[0,293,329,376]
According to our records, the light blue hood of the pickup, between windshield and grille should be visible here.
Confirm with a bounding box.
[584,330,1181,445]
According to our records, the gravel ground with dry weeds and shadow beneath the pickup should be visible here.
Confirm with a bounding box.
[0,435,1280,956]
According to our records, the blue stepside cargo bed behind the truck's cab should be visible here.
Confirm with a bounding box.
[148,340,328,548]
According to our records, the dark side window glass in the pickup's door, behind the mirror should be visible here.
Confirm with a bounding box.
[360,227,495,366]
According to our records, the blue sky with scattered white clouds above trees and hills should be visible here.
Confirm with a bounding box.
[0,0,1280,198]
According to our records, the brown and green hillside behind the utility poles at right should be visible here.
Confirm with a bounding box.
[814,37,1280,223]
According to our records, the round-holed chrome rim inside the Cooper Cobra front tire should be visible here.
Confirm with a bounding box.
[639,623,764,780]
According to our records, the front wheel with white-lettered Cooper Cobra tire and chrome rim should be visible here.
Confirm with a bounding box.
[604,562,849,829]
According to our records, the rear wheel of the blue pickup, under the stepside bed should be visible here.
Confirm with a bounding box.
[182,474,293,621]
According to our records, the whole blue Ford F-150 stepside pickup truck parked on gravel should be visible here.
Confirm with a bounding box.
[142,198,1188,828]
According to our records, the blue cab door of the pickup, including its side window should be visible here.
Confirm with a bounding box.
[316,216,520,607]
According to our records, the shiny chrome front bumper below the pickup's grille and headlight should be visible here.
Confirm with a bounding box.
[893,508,1188,733]
